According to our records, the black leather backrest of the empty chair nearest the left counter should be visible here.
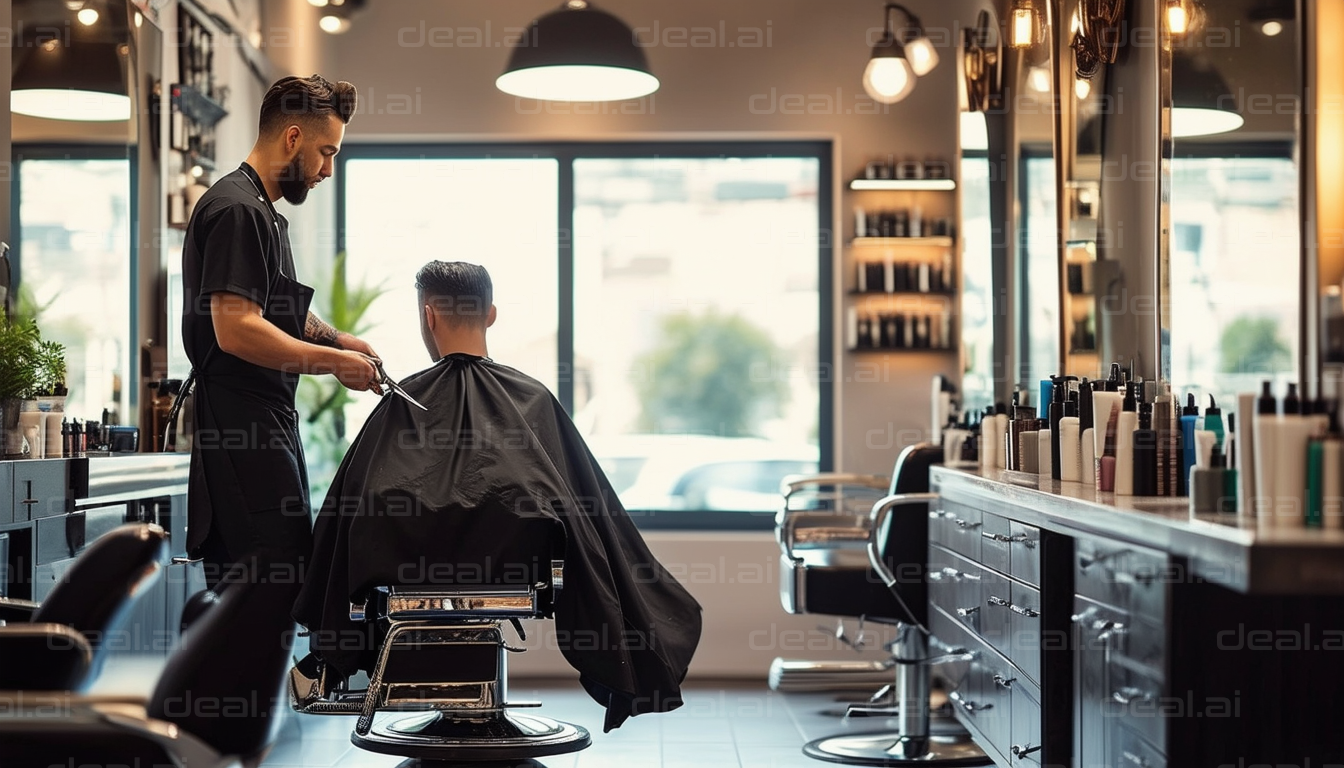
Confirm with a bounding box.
[32,523,168,642]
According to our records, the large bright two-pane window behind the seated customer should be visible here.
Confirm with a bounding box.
[336,144,831,527]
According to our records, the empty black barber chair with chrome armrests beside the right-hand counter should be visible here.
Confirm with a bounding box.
[777,444,991,765]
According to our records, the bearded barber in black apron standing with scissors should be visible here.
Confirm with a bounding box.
[183,75,380,592]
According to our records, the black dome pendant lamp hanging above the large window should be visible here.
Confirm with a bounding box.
[495,0,659,101]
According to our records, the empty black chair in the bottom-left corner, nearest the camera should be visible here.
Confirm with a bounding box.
[0,554,294,768]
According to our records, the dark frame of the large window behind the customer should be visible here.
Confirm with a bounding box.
[331,140,836,530]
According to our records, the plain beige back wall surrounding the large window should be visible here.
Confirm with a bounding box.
[278,0,980,677]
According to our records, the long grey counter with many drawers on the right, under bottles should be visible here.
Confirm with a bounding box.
[929,464,1344,768]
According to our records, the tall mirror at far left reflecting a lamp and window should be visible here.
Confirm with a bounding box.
[9,0,163,424]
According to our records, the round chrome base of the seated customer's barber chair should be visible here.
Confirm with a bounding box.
[349,712,593,761]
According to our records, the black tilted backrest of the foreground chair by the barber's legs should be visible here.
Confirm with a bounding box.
[146,557,296,761]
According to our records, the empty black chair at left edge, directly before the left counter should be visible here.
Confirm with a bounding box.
[0,523,168,691]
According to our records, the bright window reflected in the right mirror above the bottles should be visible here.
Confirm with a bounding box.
[1169,148,1301,408]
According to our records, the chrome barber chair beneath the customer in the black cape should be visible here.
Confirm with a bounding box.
[290,535,591,761]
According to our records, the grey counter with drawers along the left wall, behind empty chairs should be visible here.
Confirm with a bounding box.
[0,453,196,654]
